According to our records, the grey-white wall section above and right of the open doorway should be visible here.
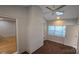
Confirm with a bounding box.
[0,6,28,53]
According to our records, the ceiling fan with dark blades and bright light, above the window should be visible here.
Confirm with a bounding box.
[46,5,66,15]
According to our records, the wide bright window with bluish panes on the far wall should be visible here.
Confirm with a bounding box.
[48,26,66,37]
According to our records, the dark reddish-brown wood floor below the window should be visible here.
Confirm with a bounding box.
[33,40,76,54]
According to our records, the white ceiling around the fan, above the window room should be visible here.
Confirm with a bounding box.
[40,5,79,20]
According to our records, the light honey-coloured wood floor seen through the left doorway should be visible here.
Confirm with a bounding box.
[0,37,16,54]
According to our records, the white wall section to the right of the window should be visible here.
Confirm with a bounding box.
[64,25,78,49]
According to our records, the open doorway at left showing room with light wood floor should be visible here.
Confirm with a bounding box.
[0,17,17,54]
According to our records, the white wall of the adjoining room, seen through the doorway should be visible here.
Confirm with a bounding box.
[0,21,16,37]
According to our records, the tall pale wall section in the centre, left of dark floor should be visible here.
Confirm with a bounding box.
[28,6,44,53]
